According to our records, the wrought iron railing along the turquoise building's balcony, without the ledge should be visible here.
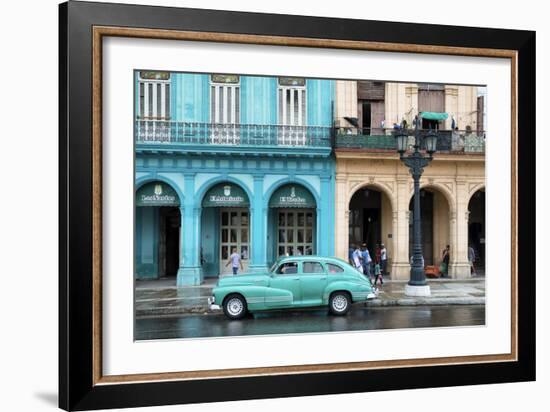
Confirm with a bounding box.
[135,120,333,148]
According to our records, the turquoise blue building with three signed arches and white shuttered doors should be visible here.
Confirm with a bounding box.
[134,71,335,285]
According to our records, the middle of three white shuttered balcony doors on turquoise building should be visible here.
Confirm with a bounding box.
[210,74,241,144]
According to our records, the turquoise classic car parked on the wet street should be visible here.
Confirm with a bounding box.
[208,256,377,319]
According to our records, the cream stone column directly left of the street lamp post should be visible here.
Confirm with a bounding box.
[392,175,411,280]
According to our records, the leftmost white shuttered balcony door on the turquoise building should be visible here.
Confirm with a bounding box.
[137,71,170,142]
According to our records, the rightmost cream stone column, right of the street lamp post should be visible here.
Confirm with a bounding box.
[449,181,471,279]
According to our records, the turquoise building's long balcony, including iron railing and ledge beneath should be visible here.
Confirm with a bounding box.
[134,120,333,155]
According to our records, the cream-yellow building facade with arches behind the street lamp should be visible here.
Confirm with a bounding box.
[335,81,485,279]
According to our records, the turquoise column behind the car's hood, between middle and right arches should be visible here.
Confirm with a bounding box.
[248,175,267,272]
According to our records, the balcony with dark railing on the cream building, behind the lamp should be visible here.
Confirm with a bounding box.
[335,128,485,154]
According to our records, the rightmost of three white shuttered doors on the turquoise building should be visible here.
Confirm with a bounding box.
[277,77,307,146]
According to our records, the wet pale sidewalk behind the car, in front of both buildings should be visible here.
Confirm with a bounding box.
[135,277,485,317]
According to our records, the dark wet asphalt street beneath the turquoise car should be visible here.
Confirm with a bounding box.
[135,305,485,340]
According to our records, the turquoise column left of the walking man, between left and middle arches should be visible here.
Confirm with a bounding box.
[177,173,203,286]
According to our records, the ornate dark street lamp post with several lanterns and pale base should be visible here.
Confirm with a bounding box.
[394,116,437,296]
